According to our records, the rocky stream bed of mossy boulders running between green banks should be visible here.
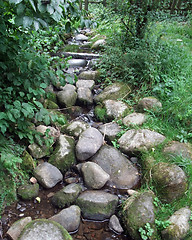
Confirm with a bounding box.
[0,30,192,240]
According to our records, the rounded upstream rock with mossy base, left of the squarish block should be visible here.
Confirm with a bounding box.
[57,84,77,107]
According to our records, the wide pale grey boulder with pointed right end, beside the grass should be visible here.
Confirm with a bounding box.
[118,129,165,153]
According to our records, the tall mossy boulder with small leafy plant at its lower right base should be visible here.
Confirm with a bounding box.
[123,191,157,240]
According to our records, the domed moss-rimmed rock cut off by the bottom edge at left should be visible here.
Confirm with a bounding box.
[18,219,72,240]
